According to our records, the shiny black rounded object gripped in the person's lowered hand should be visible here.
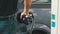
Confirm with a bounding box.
[17,12,34,25]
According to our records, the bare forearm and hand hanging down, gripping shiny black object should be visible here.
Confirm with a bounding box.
[21,0,32,15]
